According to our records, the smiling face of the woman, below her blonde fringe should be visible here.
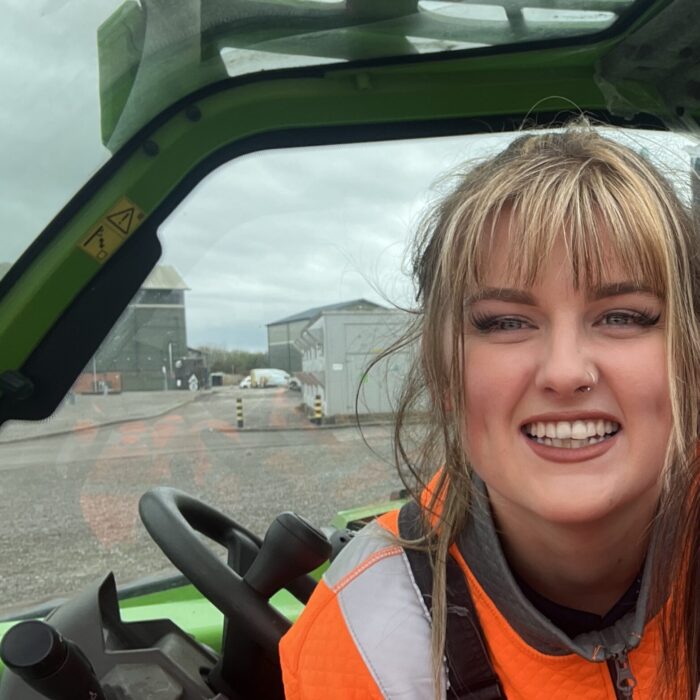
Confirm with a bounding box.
[463,217,672,524]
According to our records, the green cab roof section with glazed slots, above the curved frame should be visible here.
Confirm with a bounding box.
[97,0,640,152]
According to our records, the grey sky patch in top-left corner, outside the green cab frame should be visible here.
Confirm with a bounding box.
[0,0,121,260]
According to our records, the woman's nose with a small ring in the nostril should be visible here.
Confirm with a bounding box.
[535,325,598,397]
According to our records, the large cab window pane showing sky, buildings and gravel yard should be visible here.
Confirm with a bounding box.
[0,132,692,615]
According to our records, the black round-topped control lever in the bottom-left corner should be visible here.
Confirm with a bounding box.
[0,620,106,700]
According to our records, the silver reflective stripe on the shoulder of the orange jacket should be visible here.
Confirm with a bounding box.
[324,524,442,700]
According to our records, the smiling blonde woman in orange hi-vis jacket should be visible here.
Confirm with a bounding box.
[280,124,700,700]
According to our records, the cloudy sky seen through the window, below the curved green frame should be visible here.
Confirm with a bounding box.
[161,128,700,349]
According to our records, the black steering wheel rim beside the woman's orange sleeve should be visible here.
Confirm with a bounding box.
[139,486,290,657]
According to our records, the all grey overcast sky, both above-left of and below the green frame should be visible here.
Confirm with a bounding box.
[0,0,688,350]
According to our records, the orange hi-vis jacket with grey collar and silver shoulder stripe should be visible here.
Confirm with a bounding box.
[280,482,677,700]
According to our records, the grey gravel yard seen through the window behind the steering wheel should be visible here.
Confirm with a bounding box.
[0,387,400,616]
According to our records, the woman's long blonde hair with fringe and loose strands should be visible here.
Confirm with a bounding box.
[388,120,700,697]
